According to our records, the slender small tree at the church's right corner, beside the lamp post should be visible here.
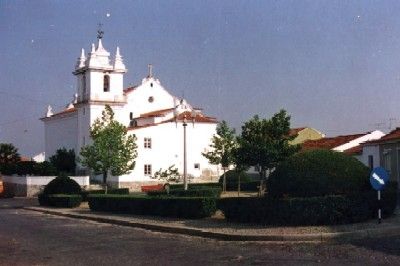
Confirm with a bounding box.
[202,121,237,192]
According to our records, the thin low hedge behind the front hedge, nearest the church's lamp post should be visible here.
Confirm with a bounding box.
[147,186,222,198]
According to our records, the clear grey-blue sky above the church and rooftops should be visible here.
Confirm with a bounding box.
[0,0,400,156]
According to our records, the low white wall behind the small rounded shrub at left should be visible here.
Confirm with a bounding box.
[1,176,89,197]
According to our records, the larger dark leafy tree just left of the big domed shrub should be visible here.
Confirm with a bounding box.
[236,110,300,194]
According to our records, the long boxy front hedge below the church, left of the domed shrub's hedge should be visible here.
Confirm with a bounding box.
[88,194,216,218]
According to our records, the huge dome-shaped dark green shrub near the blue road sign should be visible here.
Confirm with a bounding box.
[267,150,370,198]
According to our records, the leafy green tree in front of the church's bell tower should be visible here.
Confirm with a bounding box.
[80,105,137,189]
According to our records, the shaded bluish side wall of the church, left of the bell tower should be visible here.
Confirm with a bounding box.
[44,112,78,160]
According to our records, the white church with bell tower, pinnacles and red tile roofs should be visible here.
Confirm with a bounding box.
[41,34,219,189]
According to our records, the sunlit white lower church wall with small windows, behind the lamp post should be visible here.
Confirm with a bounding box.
[120,122,218,182]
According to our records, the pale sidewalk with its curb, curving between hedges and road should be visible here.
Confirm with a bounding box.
[24,203,400,242]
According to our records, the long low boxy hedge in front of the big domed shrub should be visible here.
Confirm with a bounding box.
[218,184,396,225]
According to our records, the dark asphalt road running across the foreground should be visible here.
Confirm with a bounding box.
[0,206,400,265]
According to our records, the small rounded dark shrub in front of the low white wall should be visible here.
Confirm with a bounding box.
[43,174,81,195]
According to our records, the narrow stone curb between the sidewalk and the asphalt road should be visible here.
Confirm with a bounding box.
[22,207,400,242]
